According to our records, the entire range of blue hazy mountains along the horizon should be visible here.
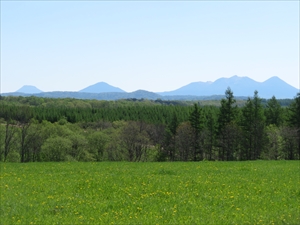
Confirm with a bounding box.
[2,76,298,100]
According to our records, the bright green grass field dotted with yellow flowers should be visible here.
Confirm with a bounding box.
[0,161,300,224]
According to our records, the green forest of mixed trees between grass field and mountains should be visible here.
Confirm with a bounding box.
[0,88,300,163]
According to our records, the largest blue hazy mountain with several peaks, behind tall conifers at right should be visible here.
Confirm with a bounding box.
[158,76,298,99]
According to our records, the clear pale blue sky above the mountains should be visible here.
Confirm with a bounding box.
[0,1,299,93]
